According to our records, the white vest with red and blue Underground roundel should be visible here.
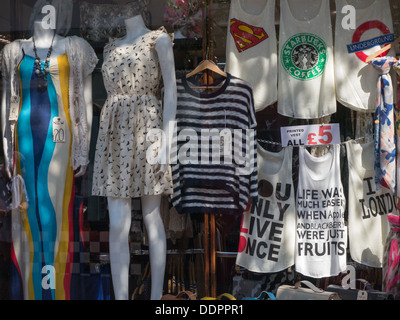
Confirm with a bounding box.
[335,0,394,112]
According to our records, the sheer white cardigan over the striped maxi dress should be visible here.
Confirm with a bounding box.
[0,36,98,170]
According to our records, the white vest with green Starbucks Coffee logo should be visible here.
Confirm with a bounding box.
[278,0,336,119]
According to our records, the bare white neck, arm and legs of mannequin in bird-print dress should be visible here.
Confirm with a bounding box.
[107,15,177,300]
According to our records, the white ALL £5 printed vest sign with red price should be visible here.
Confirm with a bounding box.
[281,123,340,147]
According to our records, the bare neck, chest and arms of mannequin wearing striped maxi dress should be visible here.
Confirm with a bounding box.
[1,19,93,177]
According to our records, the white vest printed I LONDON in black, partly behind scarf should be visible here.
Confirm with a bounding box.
[346,141,390,268]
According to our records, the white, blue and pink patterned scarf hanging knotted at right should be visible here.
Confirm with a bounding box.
[370,57,397,192]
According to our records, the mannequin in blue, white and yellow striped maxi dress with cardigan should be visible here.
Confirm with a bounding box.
[1,18,98,300]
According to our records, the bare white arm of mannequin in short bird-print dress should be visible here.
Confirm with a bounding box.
[155,34,177,173]
